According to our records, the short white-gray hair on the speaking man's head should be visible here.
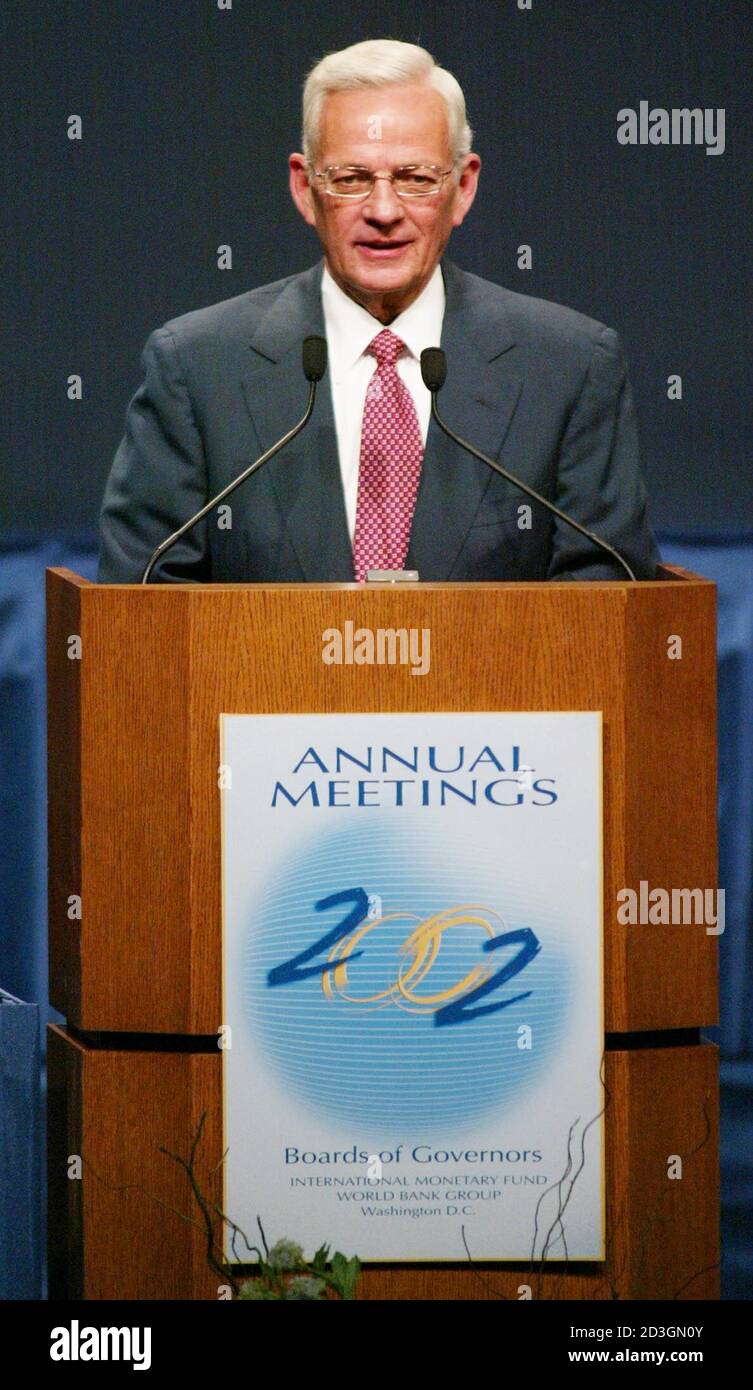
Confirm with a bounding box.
[303,39,474,171]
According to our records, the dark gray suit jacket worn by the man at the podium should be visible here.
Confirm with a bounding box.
[99,260,657,582]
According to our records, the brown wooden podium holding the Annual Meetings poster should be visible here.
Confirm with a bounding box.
[47,567,720,1300]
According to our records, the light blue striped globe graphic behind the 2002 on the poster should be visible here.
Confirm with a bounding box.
[242,816,572,1138]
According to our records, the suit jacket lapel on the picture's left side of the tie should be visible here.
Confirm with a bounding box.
[242,261,353,582]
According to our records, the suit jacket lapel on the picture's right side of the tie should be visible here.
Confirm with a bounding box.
[406,260,522,580]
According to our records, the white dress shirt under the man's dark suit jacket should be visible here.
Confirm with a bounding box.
[321,265,445,541]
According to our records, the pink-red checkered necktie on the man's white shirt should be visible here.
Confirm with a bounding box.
[353,328,424,582]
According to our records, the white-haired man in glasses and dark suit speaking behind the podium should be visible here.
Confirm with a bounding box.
[99,40,657,582]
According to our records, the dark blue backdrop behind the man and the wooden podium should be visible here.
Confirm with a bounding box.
[0,0,753,1297]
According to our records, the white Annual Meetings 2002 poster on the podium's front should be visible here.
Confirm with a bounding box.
[221,712,604,1262]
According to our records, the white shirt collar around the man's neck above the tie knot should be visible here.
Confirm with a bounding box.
[321,264,445,384]
